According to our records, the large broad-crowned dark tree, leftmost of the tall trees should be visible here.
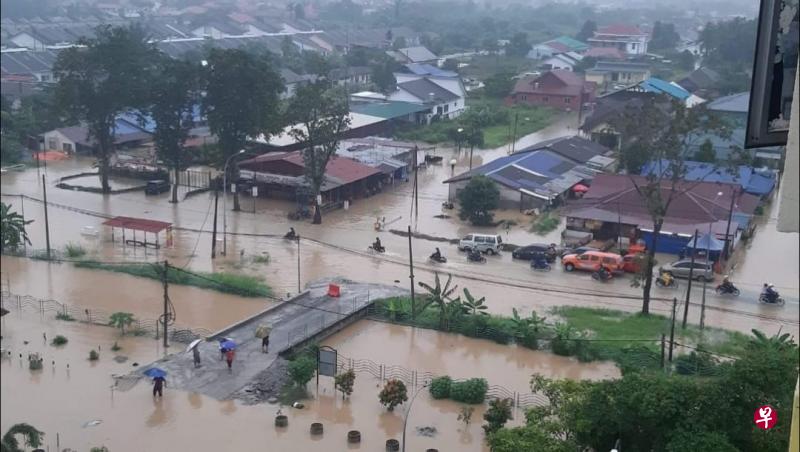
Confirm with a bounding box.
[53,25,158,193]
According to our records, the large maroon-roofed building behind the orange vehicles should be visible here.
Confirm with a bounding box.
[562,174,759,254]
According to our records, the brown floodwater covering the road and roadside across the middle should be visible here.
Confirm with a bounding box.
[2,121,800,340]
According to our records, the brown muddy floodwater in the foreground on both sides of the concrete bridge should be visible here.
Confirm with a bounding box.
[0,310,617,452]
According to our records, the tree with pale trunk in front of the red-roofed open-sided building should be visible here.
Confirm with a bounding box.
[287,79,350,224]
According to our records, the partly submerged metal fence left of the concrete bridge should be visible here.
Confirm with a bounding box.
[0,292,213,343]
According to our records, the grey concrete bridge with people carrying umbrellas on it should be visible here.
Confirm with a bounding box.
[137,281,408,402]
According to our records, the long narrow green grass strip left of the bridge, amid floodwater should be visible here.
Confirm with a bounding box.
[75,260,272,297]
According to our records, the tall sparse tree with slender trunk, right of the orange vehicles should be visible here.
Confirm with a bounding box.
[611,97,729,314]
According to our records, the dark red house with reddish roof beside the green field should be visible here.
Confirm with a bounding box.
[510,69,595,110]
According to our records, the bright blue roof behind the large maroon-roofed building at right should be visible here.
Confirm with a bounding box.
[642,161,776,198]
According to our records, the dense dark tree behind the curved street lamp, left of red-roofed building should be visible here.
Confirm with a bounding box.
[202,48,283,210]
